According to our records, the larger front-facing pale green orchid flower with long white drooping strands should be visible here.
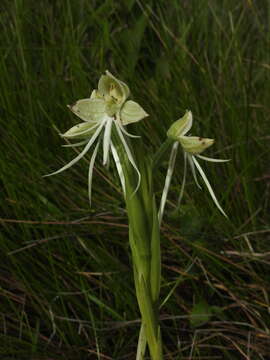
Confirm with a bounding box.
[45,71,148,204]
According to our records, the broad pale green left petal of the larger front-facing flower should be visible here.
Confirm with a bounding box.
[68,98,106,123]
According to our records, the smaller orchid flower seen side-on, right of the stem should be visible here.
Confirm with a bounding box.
[159,111,229,223]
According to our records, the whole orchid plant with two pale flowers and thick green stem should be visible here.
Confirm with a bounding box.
[46,71,227,360]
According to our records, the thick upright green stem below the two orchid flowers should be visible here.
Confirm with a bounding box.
[114,134,163,360]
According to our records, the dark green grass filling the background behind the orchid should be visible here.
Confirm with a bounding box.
[0,0,270,360]
